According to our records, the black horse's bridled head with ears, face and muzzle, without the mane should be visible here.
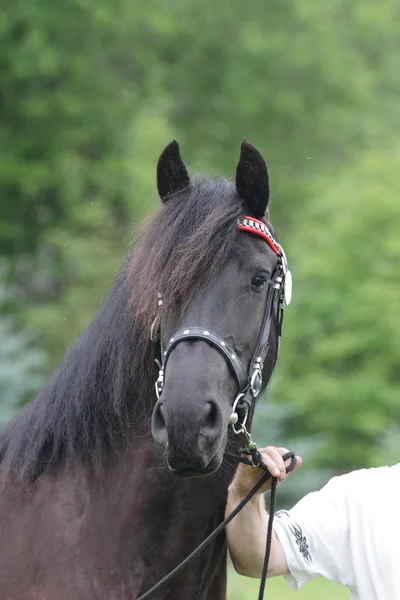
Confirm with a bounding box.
[152,141,291,477]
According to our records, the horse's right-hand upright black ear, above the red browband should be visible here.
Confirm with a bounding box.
[236,140,269,218]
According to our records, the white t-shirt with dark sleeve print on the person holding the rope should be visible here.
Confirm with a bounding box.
[274,464,400,600]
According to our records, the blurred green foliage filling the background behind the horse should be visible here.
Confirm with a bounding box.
[0,0,400,495]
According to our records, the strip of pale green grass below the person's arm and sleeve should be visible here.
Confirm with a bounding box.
[228,569,349,600]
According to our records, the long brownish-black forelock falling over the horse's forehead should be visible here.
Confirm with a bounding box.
[128,177,242,331]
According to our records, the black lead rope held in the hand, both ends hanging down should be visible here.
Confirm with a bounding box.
[137,451,296,600]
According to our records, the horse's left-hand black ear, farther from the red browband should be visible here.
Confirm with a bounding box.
[157,140,190,202]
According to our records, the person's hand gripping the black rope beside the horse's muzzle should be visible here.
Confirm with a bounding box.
[229,446,302,499]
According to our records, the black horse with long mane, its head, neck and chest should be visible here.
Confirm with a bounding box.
[0,141,290,600]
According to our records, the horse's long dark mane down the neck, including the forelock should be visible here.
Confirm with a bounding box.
[0,178,242,481]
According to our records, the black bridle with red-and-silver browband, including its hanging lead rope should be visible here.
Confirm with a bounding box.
[141,216,296,600]
